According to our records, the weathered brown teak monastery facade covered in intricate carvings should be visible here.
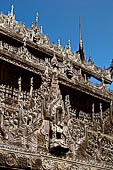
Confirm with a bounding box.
[0,6,113,170]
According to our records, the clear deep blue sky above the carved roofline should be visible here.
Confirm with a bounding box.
[0,0,113,89]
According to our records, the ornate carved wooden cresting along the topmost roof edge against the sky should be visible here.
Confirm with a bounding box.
[0,10,112,82]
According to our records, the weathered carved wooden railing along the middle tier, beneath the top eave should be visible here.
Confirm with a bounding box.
[0,41,113,100]
